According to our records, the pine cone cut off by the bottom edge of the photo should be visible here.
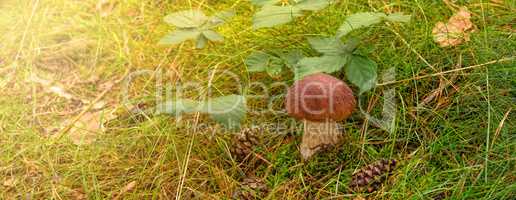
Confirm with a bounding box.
[232,178,269,200]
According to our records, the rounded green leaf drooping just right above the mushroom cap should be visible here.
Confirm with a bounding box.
[345,55,377,93]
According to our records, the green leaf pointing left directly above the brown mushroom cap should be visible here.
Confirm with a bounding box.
[294,55,349,80]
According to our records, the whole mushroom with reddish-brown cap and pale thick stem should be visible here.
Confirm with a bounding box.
[285,73,356,160]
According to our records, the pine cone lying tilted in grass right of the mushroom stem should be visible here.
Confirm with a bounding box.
[349,159,396,193]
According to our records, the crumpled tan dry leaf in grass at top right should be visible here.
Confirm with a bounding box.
[432,7,473,47]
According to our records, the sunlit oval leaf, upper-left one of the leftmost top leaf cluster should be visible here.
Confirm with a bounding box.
[165,10,208,28]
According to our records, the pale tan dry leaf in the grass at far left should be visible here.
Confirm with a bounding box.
[66,110,115,145]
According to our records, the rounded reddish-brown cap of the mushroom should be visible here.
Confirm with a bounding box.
[285,73,356,122]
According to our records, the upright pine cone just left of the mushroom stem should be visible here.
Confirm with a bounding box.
[231,128,260,160]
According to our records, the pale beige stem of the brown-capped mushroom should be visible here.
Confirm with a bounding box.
[301,120,341,160]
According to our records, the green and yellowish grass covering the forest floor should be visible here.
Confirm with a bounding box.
[0,0,516,199]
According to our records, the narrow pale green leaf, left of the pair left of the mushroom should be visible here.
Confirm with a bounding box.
[155,99,202,116]
